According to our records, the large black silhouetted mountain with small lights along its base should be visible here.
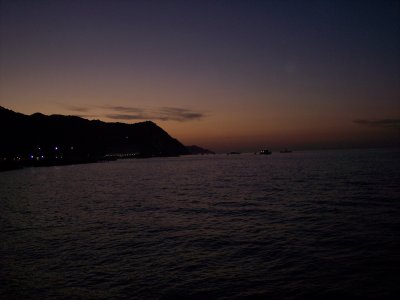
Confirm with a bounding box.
[0,106,188,169]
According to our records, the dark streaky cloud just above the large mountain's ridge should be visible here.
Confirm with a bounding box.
[104,106,205,122]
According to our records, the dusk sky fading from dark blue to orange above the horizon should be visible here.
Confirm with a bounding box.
[0,0,400,152]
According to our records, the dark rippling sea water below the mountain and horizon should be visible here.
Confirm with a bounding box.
[0,149,400,299]
